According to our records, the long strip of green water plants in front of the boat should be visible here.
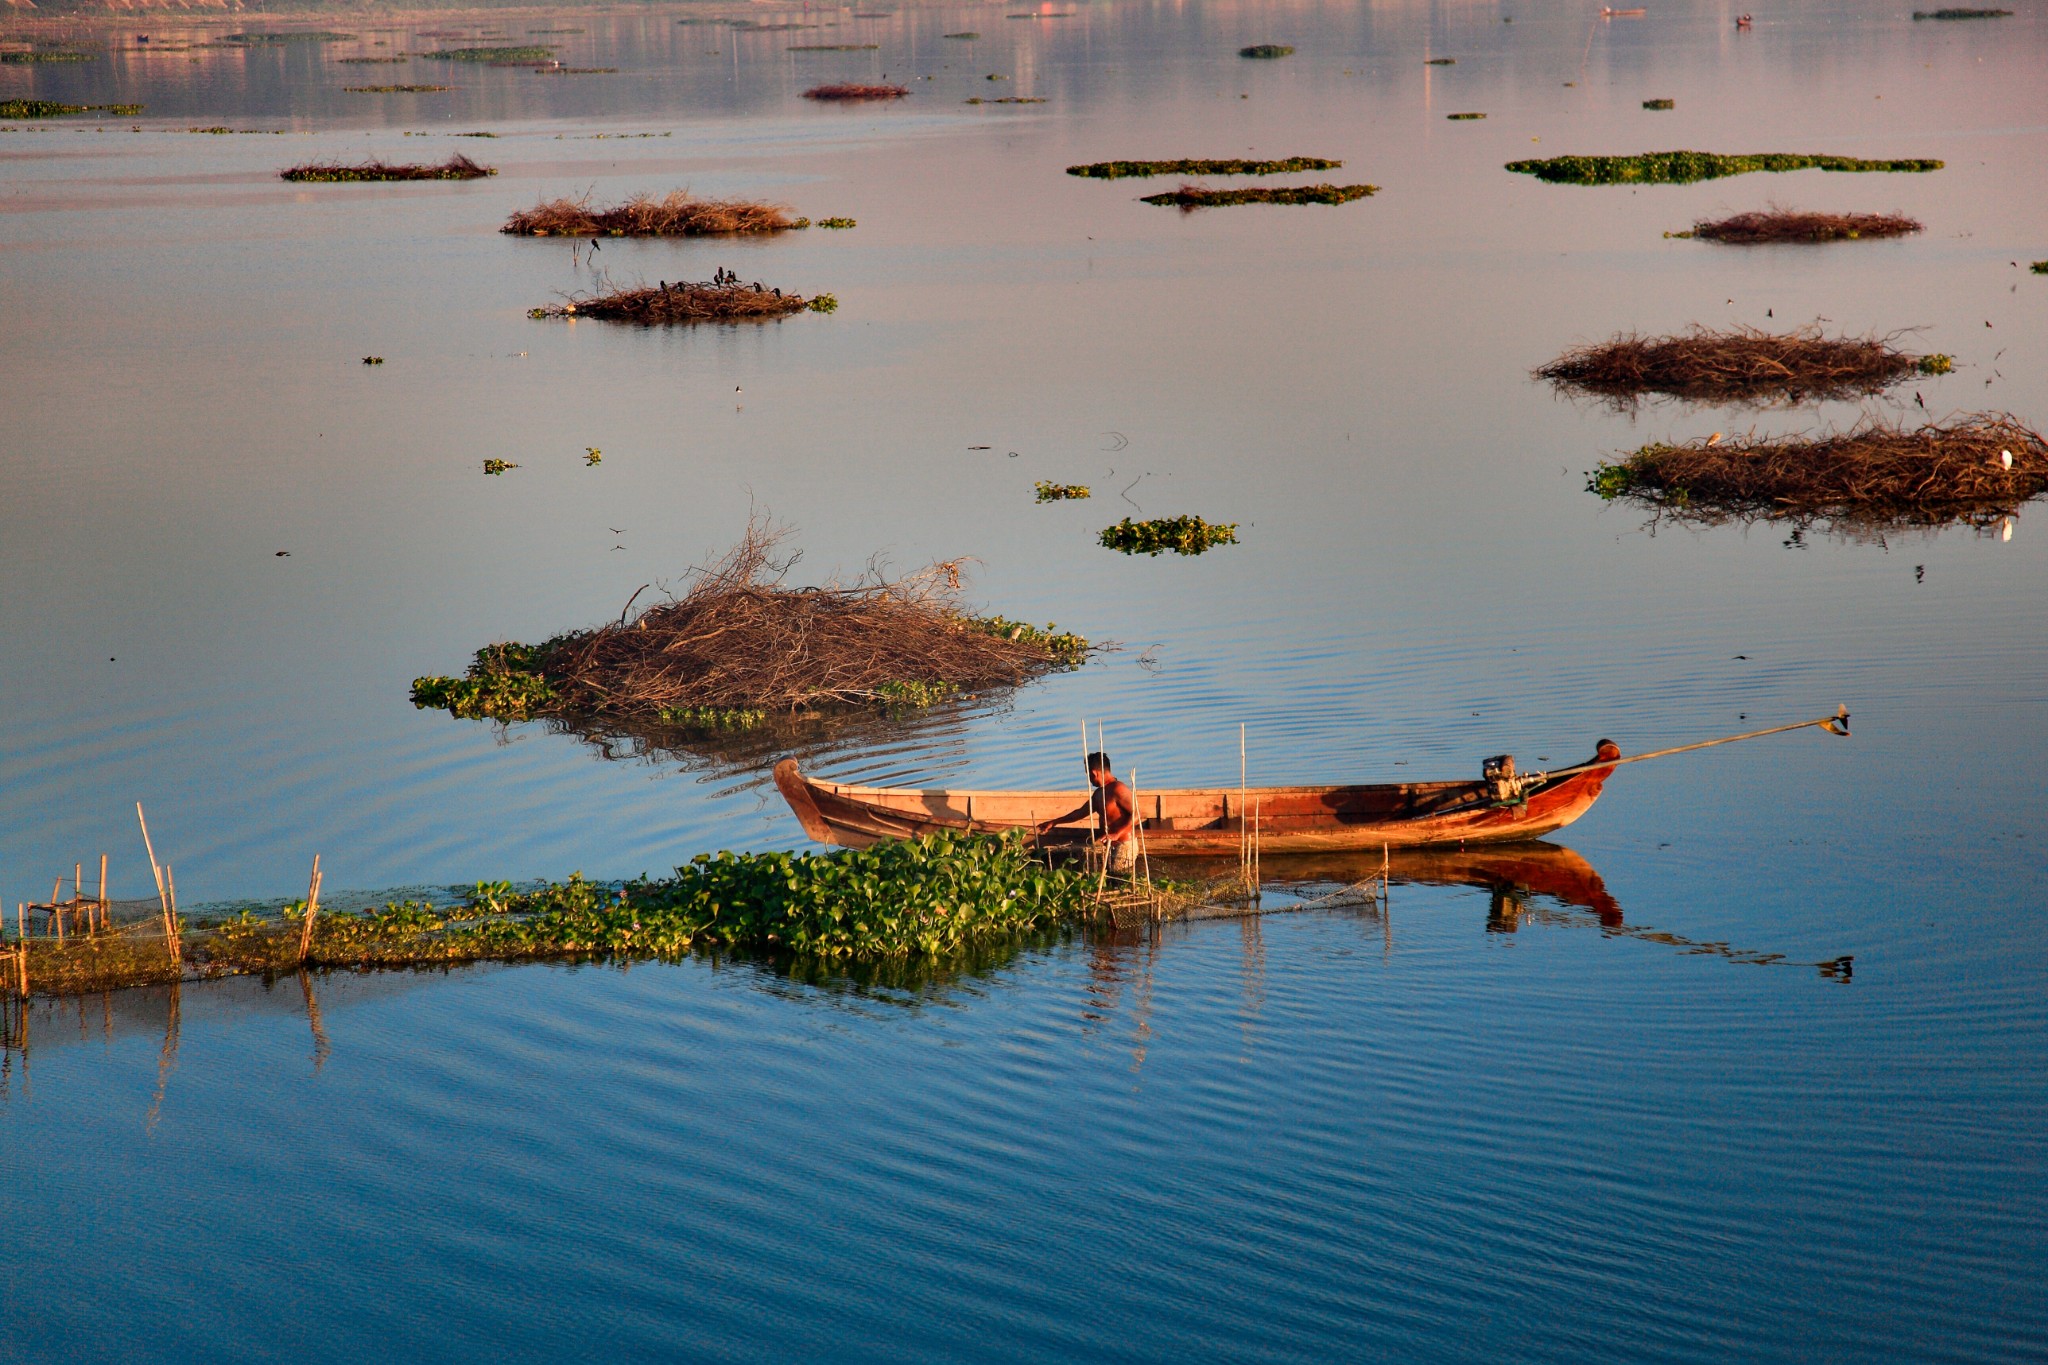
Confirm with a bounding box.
[0,833,1122,995]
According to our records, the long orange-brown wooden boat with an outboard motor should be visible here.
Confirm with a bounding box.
[774,739,1622,857]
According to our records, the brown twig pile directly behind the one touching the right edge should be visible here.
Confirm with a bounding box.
[1536,327,1954,403]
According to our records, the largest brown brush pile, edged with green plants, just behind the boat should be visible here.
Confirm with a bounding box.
[412,524,1087,729]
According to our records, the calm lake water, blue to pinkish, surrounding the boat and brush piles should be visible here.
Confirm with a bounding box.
[0,0,2048,1361]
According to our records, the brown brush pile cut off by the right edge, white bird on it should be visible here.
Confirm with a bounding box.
[1587,413,2048,526]
